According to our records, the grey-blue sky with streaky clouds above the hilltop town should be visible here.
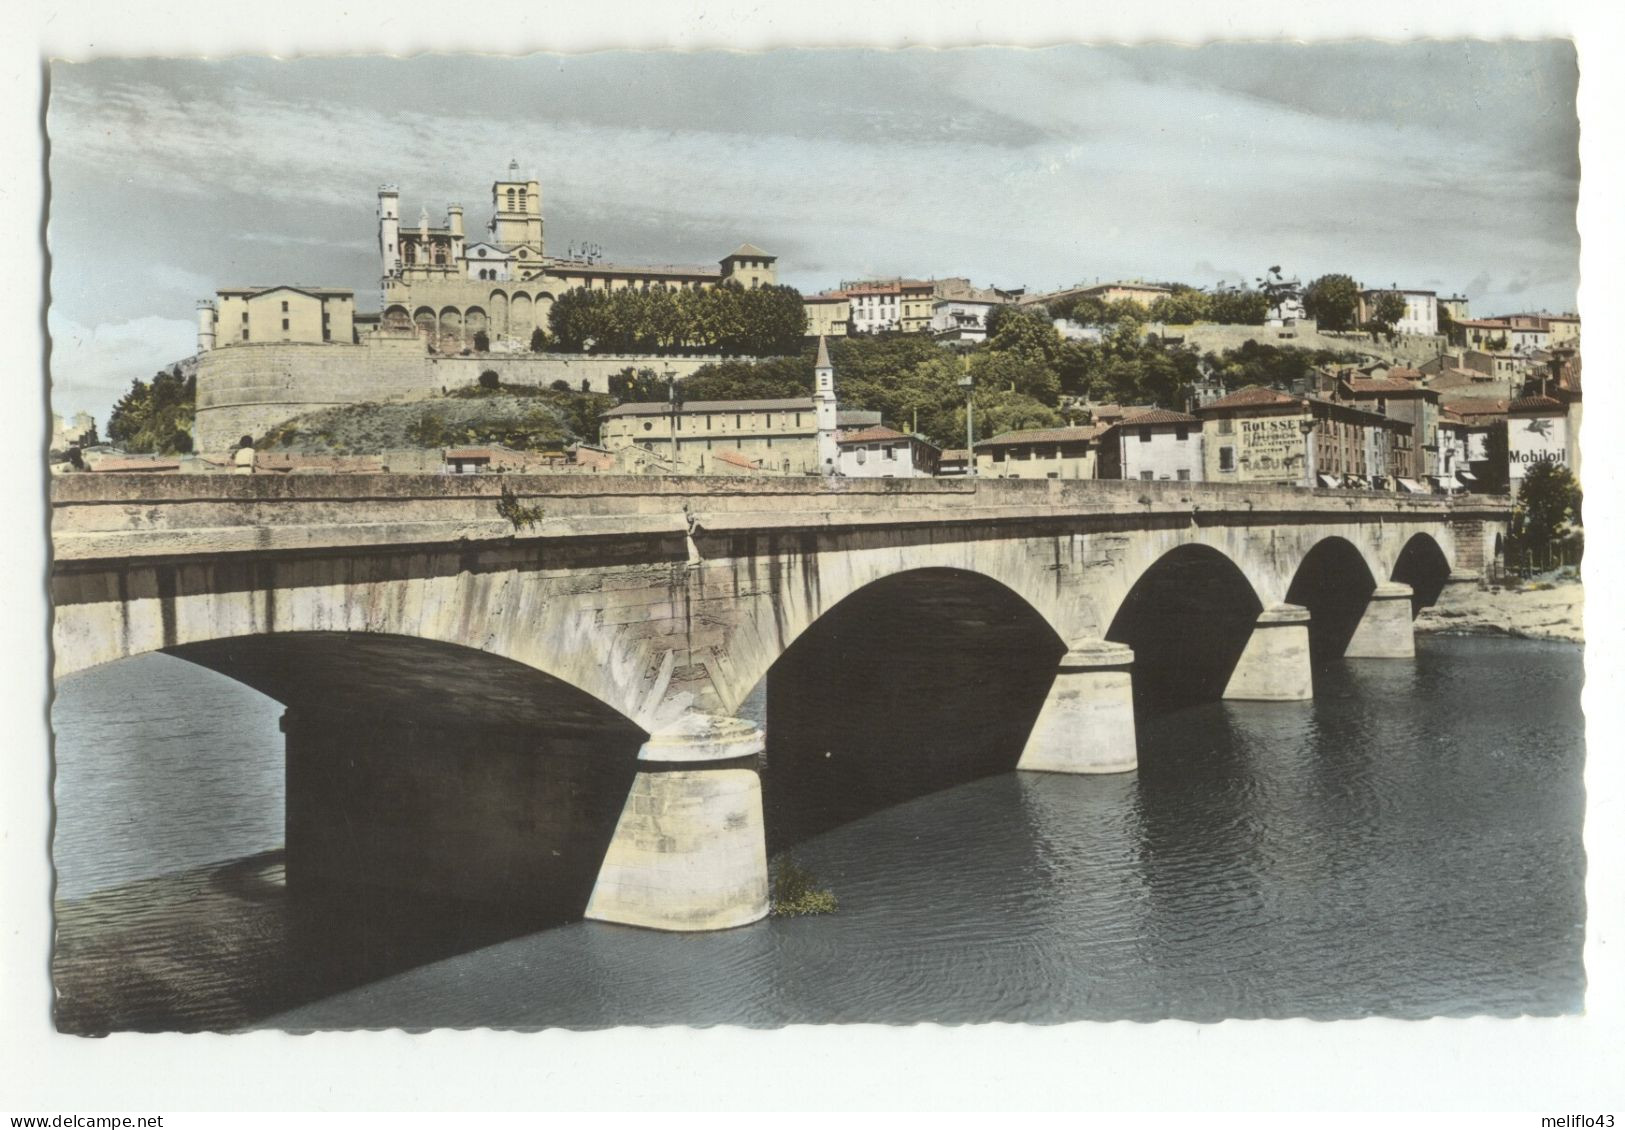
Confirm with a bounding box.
[46,41,1580,423]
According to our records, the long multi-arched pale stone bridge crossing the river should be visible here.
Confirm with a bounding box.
[50,475,1508,930]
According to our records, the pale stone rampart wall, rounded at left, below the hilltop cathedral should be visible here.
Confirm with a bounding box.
[192,337,737,450]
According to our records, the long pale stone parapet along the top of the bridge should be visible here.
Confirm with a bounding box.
[50,475,1510,564]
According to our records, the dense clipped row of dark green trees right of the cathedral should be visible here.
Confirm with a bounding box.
[546,281,806,356]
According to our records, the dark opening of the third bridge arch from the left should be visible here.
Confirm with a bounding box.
[1107,545,1264,714]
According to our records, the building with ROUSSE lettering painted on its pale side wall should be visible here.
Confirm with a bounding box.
[1189,385,1424,491]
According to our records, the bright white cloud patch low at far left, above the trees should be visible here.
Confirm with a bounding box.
[47,311,197,428]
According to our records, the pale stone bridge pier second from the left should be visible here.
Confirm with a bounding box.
[1016,639,1139,772]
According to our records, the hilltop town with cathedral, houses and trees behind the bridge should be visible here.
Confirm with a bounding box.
[52,163,1581,507]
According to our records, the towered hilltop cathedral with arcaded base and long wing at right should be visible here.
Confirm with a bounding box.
[379,161,775,351]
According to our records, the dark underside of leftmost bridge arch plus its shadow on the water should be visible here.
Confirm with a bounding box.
[54,632,647,1034]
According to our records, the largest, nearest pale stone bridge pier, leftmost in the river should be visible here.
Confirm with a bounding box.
[587,714,767,930]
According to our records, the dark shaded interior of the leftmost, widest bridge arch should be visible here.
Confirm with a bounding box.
[60,631,648,928]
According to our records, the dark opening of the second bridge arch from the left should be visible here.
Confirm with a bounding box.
[762,569,1066,850]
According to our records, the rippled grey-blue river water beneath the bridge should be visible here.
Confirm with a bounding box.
[54,637,1584,1032]
